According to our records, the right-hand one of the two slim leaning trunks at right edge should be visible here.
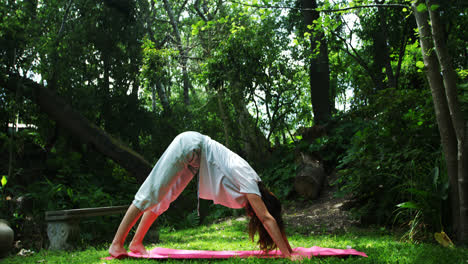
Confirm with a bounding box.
[426,0,468,242]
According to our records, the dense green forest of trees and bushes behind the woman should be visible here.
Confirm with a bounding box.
[0,0,468,248]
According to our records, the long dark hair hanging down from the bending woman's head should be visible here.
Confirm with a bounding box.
[245,182,285,252]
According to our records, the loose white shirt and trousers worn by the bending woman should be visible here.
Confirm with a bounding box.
[133,132,261,215]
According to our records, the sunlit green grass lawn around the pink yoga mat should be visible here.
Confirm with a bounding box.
[0,220,468,264]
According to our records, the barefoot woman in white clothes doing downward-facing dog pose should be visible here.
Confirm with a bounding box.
[109,132,292,258]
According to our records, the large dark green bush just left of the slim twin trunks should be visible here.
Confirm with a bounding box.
[330,89,448,235]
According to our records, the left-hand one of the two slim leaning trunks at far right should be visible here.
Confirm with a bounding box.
[412,0,462,242]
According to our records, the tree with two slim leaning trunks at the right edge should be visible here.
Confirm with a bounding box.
[412,0,468,242]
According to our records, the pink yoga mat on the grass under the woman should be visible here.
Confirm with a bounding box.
[105,246,367,260]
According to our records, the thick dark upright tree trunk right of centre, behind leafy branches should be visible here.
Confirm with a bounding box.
[302,0,332,124]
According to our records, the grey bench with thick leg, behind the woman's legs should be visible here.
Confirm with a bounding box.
[45,205,128,250]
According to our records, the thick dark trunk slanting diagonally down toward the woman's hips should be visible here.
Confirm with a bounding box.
[0,74,152,182]
